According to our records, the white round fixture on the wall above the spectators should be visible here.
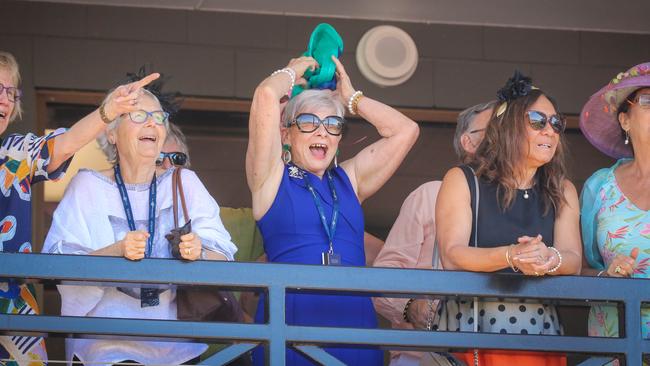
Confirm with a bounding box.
[357,25,418,86]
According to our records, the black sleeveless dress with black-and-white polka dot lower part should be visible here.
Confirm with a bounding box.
[439,165,562,335]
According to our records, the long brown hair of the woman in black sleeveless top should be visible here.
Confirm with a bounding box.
[473,89,567,215]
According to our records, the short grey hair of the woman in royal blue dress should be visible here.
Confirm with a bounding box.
[282,89,345,127]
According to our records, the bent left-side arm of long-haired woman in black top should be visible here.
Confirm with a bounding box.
[436,168,510,272]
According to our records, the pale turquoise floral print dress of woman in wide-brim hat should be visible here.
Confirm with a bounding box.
[583,160,650,338]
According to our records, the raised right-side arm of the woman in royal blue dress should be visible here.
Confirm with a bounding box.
[332,57,420,202]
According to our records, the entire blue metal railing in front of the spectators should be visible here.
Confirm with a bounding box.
[0,253,650,365]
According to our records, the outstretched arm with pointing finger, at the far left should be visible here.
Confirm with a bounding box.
[47,73,160,173]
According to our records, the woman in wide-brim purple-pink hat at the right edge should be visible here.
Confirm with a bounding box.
[580,62,650,346]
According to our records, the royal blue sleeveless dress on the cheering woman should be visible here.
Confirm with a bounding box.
[253,165,383,365]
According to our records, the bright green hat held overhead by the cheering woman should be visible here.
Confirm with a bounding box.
[291,23,343,97]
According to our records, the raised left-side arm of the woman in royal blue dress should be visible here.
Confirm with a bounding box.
[246,57,318,220]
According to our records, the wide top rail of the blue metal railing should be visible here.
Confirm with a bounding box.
[0,253,650,301]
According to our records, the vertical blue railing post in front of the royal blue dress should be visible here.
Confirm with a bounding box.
[268,285,287,366]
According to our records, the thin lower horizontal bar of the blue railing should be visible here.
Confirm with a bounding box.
[0,314,650,354]
